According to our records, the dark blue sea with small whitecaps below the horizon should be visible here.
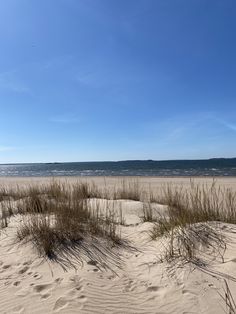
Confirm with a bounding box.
[0,158,236,177]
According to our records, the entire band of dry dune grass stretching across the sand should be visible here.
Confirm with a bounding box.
[0,179,236,262]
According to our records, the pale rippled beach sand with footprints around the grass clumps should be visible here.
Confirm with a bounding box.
[0,178,236,314]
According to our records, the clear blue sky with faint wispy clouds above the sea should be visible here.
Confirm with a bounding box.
[0,0,236,163]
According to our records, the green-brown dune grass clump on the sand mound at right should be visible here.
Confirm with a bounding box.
[151,181,236,264]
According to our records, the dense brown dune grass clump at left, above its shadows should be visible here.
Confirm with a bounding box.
[2,180,119,258]
